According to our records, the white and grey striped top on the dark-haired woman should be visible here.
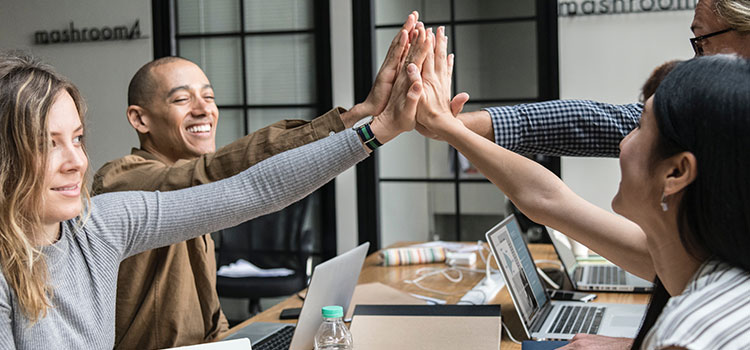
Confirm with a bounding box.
[642,260,750,350]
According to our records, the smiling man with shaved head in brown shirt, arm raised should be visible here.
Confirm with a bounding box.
[93,13,417,349]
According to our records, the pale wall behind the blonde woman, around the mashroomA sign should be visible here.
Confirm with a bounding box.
[0,0,153,171]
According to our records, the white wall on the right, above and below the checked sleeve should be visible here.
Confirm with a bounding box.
[559,10,693,210]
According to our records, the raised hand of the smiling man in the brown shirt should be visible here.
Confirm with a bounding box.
[342,11,419,127]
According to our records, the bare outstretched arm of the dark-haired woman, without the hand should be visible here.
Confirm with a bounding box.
[443,123,654,279]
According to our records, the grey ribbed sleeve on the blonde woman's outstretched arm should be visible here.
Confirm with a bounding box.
[94,130,367,257]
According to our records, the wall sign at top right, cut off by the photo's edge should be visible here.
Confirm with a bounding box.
[557,0,698,17]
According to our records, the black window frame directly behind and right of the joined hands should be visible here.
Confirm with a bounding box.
[352,0,560,252]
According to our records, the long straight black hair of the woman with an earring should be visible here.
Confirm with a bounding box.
[633,55,750,349]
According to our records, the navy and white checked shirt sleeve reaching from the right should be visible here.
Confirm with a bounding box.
[485,100,643,157]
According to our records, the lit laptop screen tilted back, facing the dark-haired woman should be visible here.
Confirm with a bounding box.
[487,215,549,329]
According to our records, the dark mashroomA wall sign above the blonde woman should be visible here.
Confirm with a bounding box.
[34,20,148,45]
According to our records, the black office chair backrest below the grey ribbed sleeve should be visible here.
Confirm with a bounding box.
[217,198,314,271]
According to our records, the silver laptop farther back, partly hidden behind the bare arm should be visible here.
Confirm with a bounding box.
[547,227,654,293]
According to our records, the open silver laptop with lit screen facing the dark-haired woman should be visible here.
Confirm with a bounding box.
[486,215,646,340]
